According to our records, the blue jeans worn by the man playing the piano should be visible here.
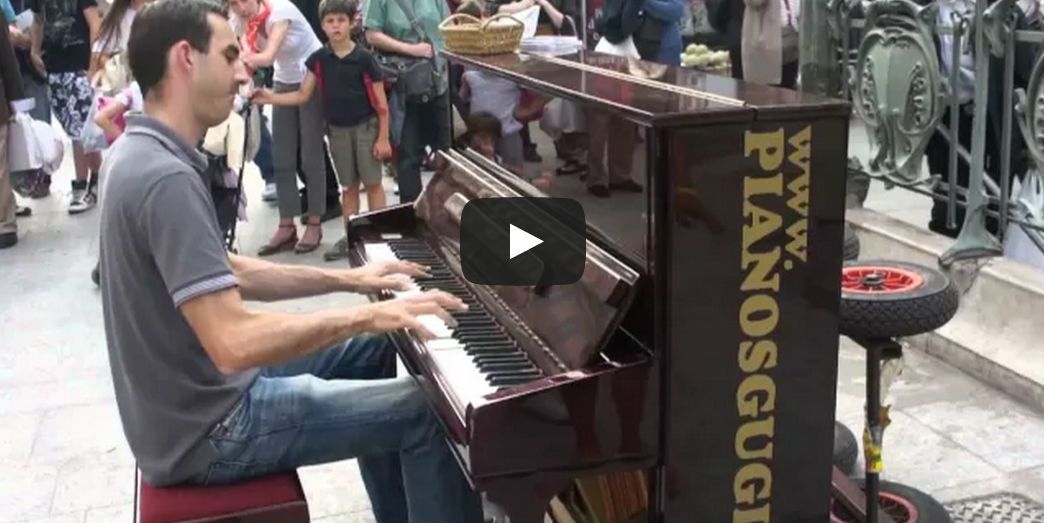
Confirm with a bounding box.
[199,335,482,523]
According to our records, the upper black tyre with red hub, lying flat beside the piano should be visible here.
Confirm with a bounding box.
[840,260,958,339]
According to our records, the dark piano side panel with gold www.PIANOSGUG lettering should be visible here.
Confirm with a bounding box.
[658,115,848,523]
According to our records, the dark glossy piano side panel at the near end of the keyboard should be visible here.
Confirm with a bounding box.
[469,350,660,483]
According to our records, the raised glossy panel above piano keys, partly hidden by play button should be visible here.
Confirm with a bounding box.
[414,150,639,370]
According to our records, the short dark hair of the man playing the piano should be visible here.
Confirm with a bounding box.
[127,0,229,95]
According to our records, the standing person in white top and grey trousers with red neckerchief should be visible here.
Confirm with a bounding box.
[229,0,327,256]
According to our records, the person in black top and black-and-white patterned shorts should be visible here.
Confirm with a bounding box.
[29,0,101,214]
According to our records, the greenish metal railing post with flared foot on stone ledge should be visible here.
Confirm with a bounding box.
[939,0,1002,267]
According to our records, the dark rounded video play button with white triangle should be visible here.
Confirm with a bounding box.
[460,197,587,286]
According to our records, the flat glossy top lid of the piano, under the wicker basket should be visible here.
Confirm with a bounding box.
[445,51,850,126]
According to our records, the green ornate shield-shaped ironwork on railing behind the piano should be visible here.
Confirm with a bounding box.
[852,0,946,186]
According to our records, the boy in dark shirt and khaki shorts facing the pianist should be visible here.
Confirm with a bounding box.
[254,0,392,261]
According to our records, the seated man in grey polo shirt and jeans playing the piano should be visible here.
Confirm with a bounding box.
[100,0,482,523]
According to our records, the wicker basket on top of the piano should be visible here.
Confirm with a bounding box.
[438,13,525,54]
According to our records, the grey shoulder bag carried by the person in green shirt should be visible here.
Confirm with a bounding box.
[371,0,442,103]
